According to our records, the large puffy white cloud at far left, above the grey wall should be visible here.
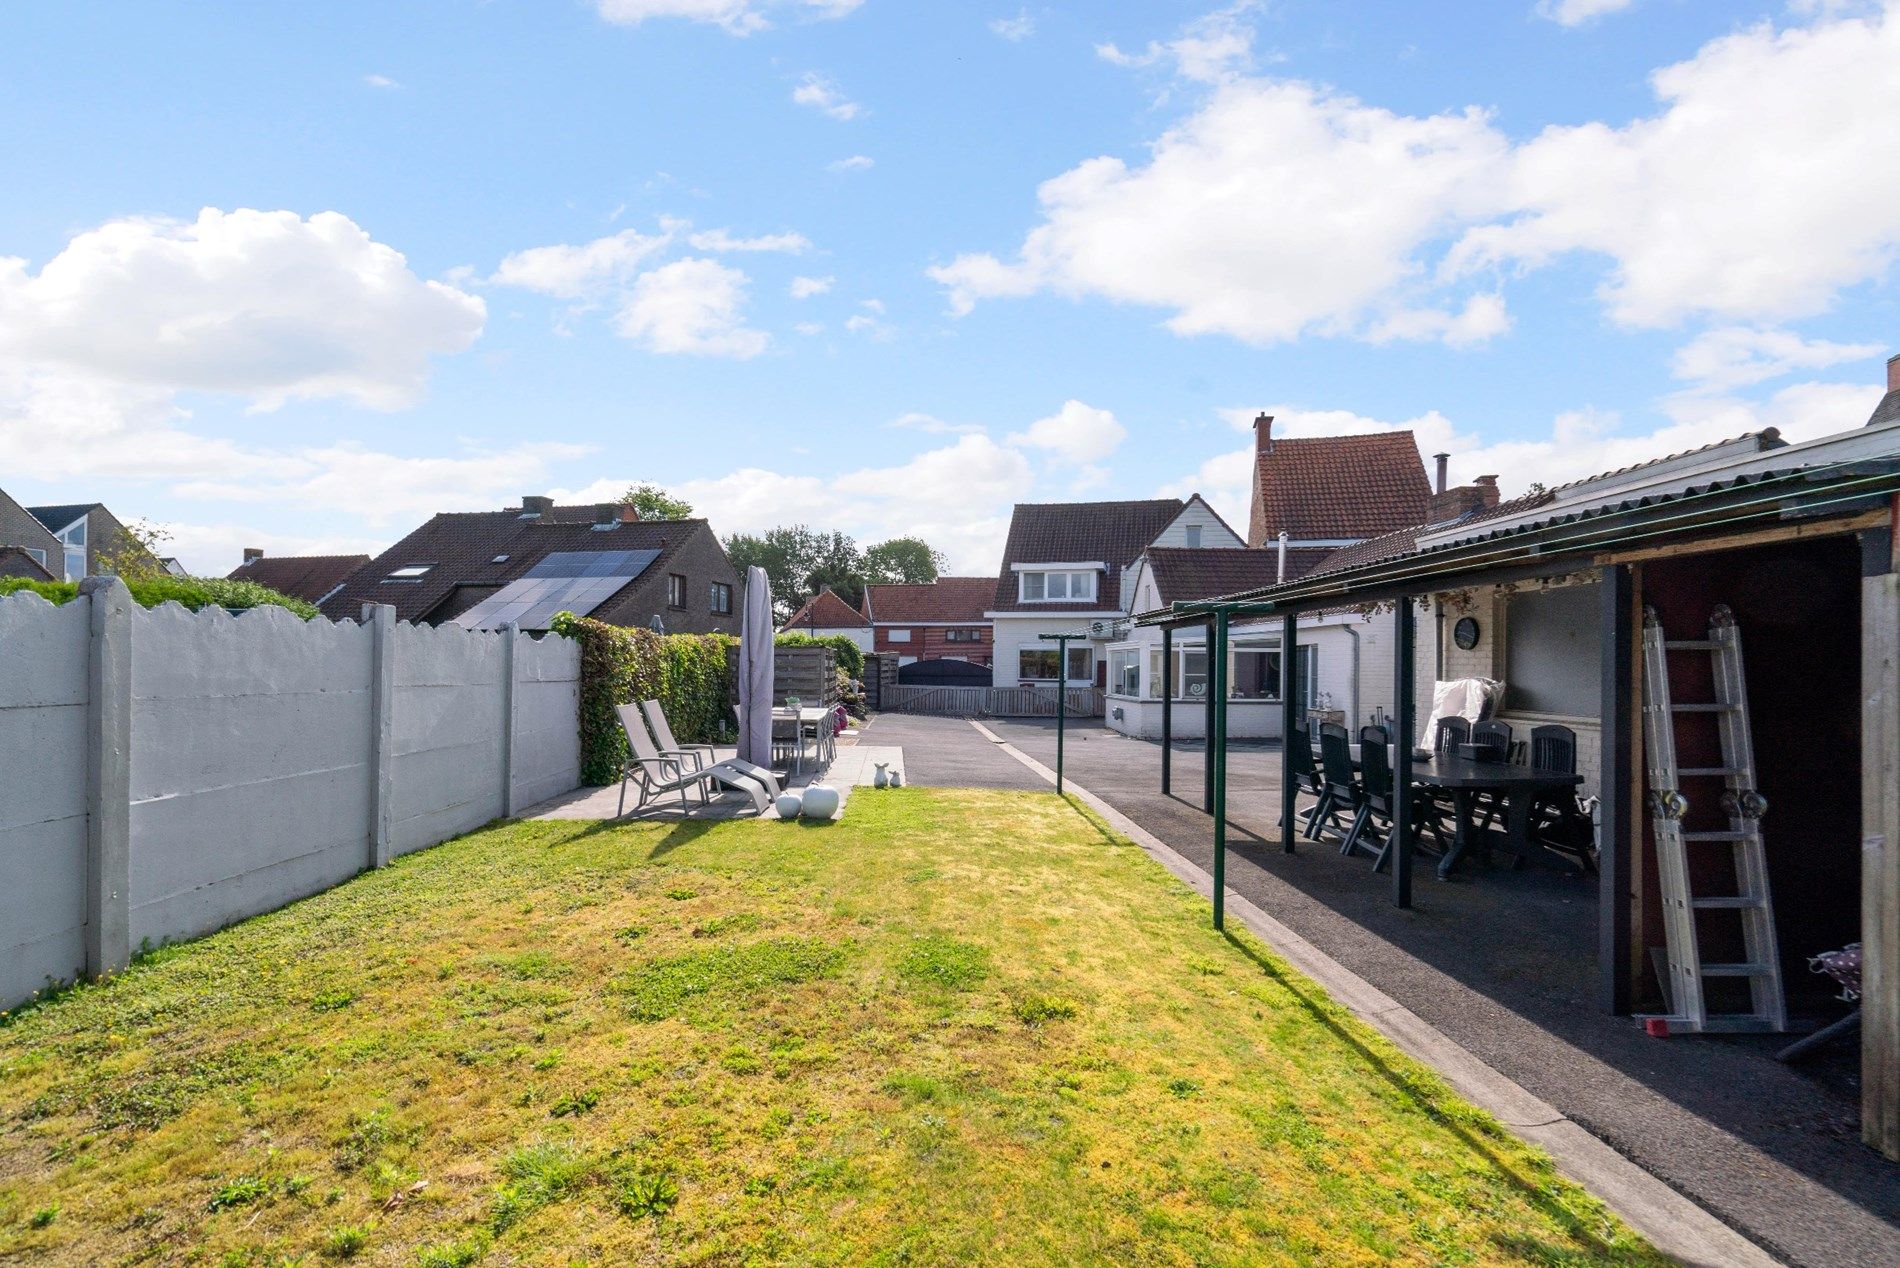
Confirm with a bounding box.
[0,207,486,409]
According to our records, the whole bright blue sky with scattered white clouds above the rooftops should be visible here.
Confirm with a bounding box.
[0,0,1900,572]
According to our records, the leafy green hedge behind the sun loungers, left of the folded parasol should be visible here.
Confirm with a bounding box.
[547,612,733,783]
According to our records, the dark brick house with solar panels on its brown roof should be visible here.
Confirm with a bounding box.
[319,496,741,635]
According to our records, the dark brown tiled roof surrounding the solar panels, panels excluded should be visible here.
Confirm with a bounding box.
[321,506,711,622]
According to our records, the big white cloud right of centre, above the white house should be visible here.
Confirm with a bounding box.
[929,80,1507,344]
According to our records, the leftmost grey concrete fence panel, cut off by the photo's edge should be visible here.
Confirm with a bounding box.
[0,593,87,1008]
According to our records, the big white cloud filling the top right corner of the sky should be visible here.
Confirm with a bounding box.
[1454,6,1900,325]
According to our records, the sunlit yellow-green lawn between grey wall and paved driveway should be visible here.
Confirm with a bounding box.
[0,789,1663,1266]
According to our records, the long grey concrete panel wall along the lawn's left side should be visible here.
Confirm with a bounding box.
[0,582,580,1008]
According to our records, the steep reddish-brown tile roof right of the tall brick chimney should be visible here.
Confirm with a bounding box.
[1246,432,1431,546]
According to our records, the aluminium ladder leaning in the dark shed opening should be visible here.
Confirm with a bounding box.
[1644,605,1788,1032]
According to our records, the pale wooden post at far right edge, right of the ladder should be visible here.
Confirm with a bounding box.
[1860,568,1900,1160]
